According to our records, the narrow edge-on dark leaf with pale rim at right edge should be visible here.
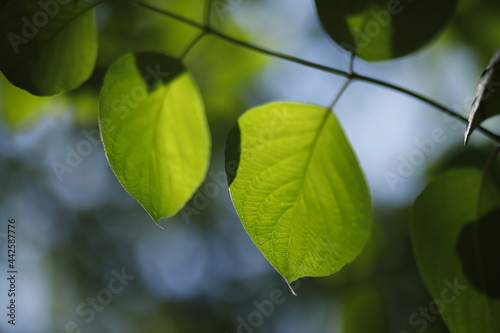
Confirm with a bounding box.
[464,49,500,144]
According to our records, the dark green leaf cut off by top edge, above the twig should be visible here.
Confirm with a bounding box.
[316,0,457,61]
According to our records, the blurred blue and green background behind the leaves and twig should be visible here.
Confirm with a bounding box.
[0,0,500,333]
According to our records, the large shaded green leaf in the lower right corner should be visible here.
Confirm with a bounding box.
[411,169,500,333]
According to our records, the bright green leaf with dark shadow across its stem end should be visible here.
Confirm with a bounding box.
[99,53,210,221]
